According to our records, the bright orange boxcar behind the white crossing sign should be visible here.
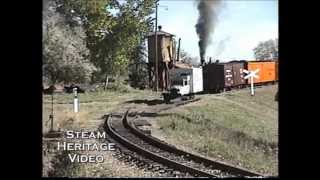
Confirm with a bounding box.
[247,61,277,84]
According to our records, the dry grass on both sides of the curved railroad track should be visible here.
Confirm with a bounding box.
[43,86,278,177]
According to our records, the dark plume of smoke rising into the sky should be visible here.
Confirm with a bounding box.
[196,0,221,65]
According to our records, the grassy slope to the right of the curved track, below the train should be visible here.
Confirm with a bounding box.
[156,86,278,175]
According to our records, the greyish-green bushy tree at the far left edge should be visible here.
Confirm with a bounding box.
[43,0,95,84]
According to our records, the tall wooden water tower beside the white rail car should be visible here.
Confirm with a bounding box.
[148,26,176,91]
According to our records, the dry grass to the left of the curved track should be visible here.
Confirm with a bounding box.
[42,89,160,177]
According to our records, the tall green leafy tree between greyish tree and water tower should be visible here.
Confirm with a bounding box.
[57,0,154,87]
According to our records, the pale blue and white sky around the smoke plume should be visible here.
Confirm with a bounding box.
[154,0,278,62]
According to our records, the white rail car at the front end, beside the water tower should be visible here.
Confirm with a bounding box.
[163,67,203,102]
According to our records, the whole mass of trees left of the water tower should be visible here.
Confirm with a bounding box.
[43,0,155,87]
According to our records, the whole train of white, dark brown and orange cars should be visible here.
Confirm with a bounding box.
[163,60,278,103]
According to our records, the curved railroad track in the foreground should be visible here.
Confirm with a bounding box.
[104,110,263,177]
